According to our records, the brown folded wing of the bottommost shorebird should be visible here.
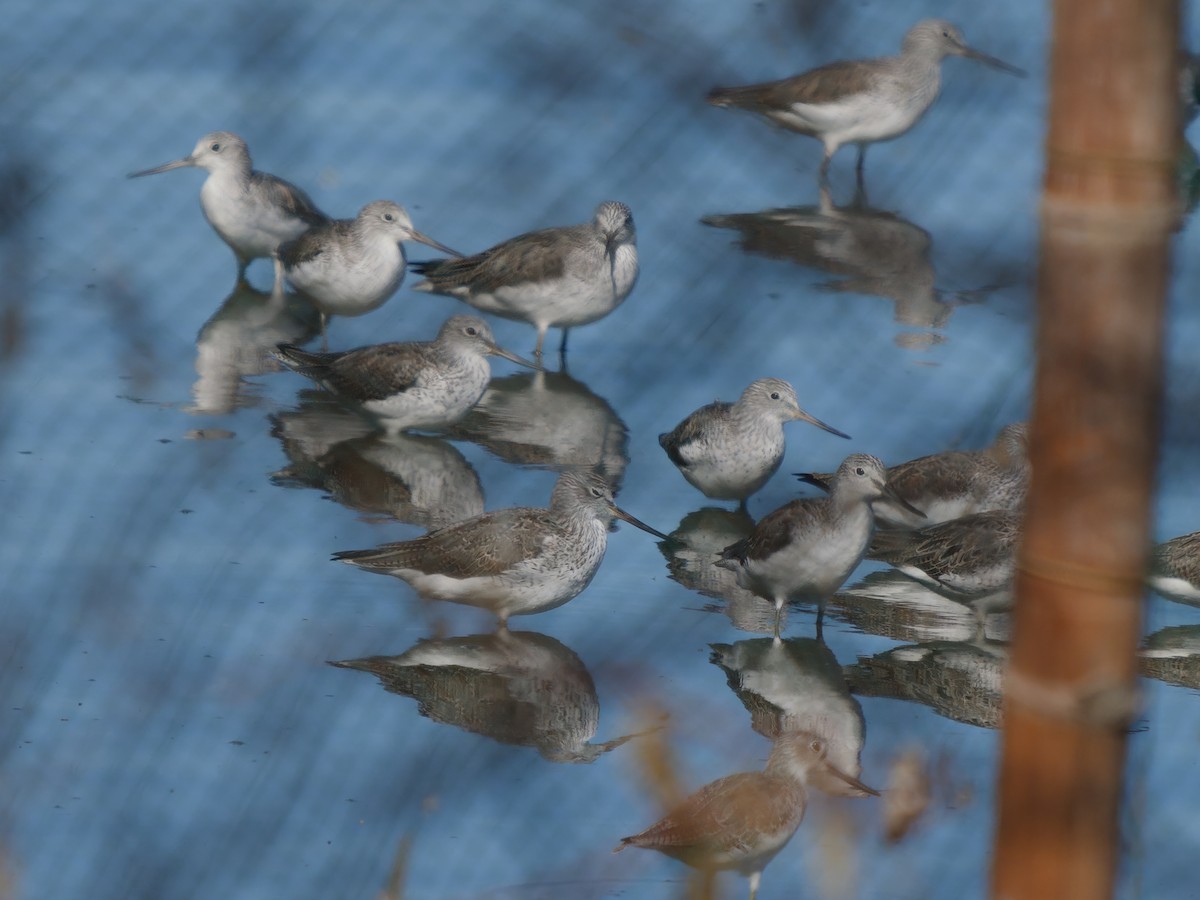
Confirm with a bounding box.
[622,772,804,864]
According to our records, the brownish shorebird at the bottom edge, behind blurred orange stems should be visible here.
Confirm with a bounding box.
[613,732,878,900]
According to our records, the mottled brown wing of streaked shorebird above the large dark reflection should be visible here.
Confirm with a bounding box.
[334,508,558,578]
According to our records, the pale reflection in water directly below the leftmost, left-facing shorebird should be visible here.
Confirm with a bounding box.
[188,278,320,415]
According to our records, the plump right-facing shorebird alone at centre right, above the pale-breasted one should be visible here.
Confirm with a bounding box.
[659,378,850,502]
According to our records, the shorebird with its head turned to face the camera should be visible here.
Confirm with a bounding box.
[413,200,637,359]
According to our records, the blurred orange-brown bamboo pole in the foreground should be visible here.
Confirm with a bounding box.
[992,0,1180,900]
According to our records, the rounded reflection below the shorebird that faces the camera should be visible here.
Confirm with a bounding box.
[443,372,629,491]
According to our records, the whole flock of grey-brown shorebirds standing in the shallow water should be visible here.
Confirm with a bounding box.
[126,20,1200,896]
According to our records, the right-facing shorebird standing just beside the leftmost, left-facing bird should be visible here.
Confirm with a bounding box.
[275,200,461,337]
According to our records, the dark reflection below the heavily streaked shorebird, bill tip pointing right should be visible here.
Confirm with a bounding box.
[330,629,637,763]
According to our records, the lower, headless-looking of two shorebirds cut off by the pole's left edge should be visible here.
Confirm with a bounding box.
[868,510,1021,596]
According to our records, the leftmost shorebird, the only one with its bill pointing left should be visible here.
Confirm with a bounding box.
[130,131,329,281]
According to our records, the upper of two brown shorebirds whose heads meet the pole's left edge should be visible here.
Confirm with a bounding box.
[797,422,1030,528]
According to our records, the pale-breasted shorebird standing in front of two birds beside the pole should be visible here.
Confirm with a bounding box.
[716,454,920,637]
